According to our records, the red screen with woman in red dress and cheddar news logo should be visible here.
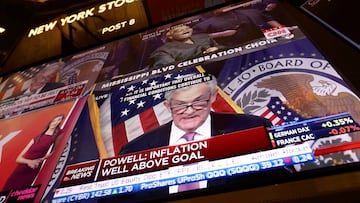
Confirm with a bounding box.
[0,98,86,202]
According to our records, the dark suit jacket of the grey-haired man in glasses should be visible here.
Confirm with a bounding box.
[120,112,271,154]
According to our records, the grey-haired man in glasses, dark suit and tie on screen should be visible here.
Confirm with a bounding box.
[120,73,271,193]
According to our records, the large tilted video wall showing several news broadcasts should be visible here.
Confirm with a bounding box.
[0,0,360,202]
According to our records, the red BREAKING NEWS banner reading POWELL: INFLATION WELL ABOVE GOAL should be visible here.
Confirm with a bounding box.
[60,127,272,187]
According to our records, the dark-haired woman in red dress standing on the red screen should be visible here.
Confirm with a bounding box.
[3,115,64,191]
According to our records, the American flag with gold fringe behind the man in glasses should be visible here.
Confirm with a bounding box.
[100,70,240,156]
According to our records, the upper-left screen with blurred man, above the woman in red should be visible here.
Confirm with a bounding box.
[0,45,109,119]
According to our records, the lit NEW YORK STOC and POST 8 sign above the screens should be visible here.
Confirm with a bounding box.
[27,0,148,39]
